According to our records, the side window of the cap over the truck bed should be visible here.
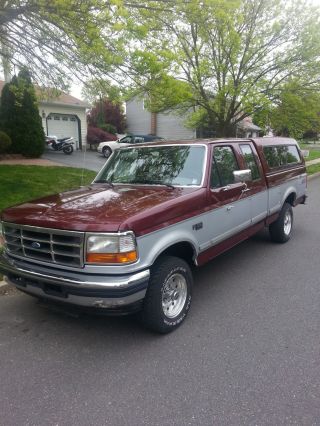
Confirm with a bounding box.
[263,145,301,169]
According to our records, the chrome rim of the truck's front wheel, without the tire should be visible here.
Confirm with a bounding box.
[162,273,188,318]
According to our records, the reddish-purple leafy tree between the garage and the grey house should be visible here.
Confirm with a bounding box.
[88,99,126,133]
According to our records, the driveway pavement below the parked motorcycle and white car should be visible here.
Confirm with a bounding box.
[42,149,106,172]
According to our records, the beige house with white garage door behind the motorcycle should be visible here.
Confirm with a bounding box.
[0,80,90,149]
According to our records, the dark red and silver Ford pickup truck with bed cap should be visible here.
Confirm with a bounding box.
[0,138,307,333]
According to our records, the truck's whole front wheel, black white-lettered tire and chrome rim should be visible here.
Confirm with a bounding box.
[142,256,193,333]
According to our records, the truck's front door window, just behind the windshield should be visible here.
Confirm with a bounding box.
[211,146,239,188]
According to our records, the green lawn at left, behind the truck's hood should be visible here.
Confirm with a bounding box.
[0,165,96,211]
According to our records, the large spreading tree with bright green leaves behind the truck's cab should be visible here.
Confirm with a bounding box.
[127,0,320,136]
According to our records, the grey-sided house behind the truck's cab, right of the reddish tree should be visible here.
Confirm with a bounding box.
[126,98,196,140]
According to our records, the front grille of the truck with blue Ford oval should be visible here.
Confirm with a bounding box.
[3,223,84,267]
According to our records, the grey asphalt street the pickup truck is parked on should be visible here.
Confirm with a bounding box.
[0,178,320,426]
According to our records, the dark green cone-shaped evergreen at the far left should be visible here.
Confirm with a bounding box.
[0,69,44,157]
